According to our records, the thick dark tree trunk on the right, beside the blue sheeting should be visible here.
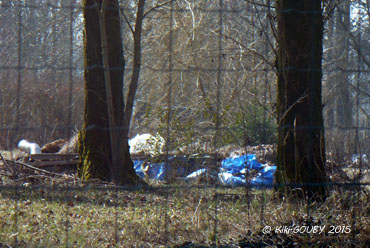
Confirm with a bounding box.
[276,0,326,201]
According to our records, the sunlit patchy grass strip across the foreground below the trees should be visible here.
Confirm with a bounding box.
[0,186,370,247]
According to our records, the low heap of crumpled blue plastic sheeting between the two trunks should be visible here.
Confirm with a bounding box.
[134,154,276,188]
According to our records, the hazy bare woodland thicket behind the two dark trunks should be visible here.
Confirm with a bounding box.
[0,0,370,159]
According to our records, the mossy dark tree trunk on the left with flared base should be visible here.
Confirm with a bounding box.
[78,0,141,184]
